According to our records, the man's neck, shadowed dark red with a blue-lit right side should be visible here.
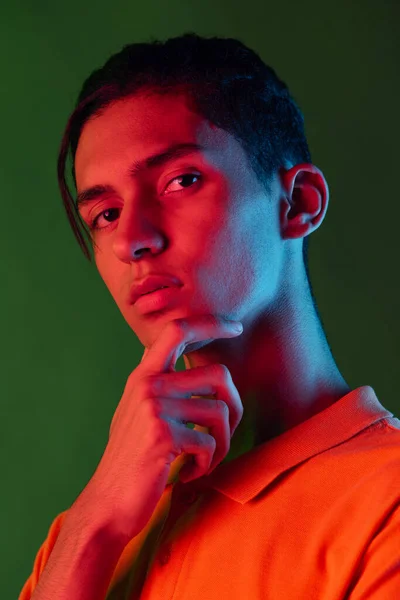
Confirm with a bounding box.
[184,280,351,462]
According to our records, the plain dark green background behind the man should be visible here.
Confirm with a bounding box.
[0,0,400,599]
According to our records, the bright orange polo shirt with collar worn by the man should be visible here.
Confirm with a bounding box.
[18,386,400,600]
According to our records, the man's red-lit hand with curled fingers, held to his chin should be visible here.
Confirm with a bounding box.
[75,315,243,543]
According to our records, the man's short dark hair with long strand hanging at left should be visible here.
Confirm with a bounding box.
[57,32,311,282]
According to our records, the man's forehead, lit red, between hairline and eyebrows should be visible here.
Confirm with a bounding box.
[75,94,245,187]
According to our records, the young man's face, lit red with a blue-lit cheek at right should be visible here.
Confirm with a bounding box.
[75,95,283,347]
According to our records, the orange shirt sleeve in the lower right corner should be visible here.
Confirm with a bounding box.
[348,506,400,600]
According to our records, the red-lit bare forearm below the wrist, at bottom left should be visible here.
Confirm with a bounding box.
[31,506,123,600]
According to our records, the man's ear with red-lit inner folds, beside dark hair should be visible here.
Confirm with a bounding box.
[279,163,329,239]
